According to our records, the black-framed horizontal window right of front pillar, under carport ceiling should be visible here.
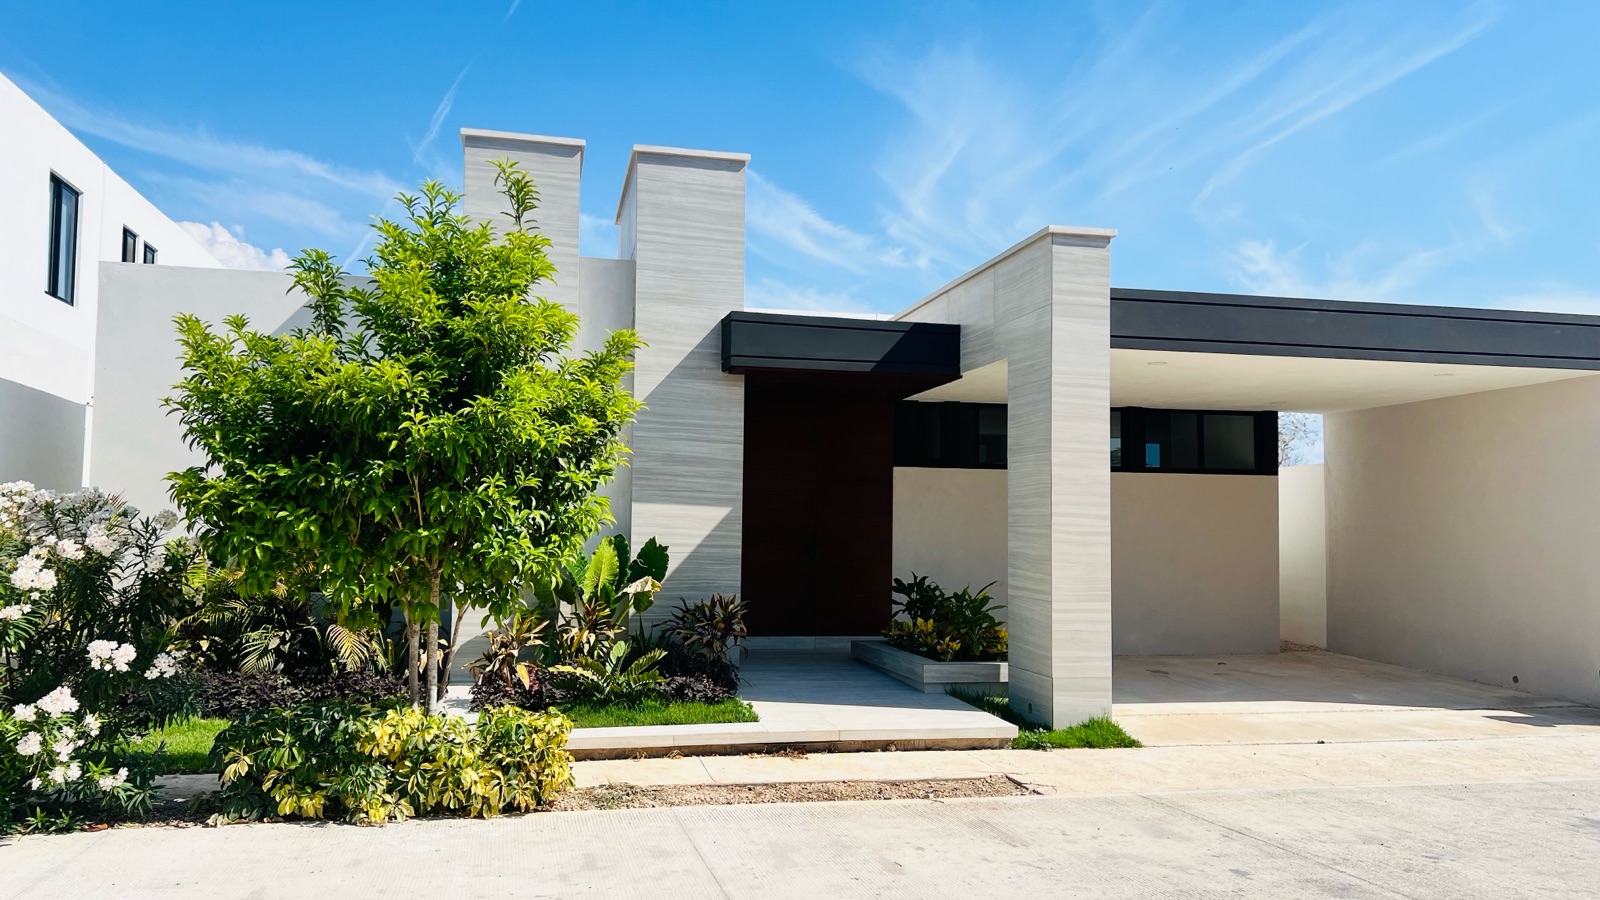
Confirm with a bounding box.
[1110,407,1278,476]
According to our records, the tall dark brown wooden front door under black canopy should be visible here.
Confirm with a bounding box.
[741,375,894,636]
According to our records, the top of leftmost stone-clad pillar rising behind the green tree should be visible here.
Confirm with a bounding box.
[461,128,584,312]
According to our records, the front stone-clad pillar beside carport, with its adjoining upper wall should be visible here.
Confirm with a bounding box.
[899,226,1115,727]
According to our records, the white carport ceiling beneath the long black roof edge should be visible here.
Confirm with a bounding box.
[1113,349,1597,413]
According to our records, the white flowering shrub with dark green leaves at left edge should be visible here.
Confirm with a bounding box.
[0,482,195,831]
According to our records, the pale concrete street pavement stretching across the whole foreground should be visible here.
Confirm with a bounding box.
[0,735,1600,900]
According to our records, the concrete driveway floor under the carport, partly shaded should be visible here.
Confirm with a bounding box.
[1114,652,1600,746]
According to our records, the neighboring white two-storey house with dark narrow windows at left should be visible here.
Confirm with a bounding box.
[0,77,219,488]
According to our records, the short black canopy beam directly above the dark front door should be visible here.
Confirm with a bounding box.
[722,312,962,378]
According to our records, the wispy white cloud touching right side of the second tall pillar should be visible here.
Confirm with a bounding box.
[744,170,923,275]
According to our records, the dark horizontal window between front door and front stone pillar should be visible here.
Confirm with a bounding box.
[894,400,1006,469]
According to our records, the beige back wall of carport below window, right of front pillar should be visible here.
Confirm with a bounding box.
[1110,472,1278,655]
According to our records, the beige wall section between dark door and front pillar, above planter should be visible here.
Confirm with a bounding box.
[885,468,1006,620]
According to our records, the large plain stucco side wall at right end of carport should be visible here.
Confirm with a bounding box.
[1325,376,1600,705]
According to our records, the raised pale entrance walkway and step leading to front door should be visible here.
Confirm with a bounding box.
[568,650,1016,757]
